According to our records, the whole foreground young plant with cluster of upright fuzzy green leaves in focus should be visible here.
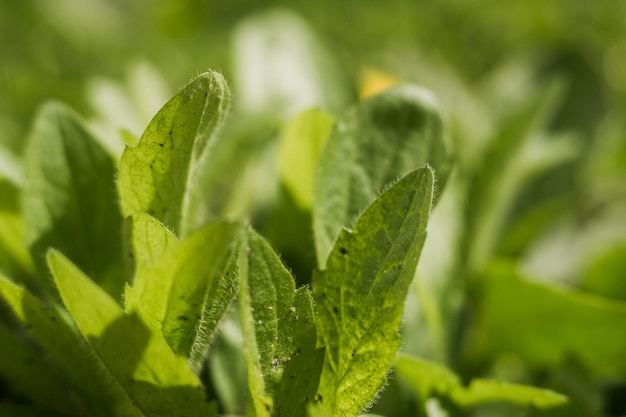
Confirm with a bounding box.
[0,72,563,417]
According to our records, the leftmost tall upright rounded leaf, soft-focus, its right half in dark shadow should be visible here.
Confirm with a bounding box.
[23,103,124,297]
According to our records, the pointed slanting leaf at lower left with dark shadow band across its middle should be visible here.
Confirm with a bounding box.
[47,251,216,417]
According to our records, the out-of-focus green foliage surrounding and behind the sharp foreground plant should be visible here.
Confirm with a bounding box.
[0,0,626,417]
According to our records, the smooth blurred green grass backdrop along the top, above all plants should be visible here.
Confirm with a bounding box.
[0,0,626,151]
